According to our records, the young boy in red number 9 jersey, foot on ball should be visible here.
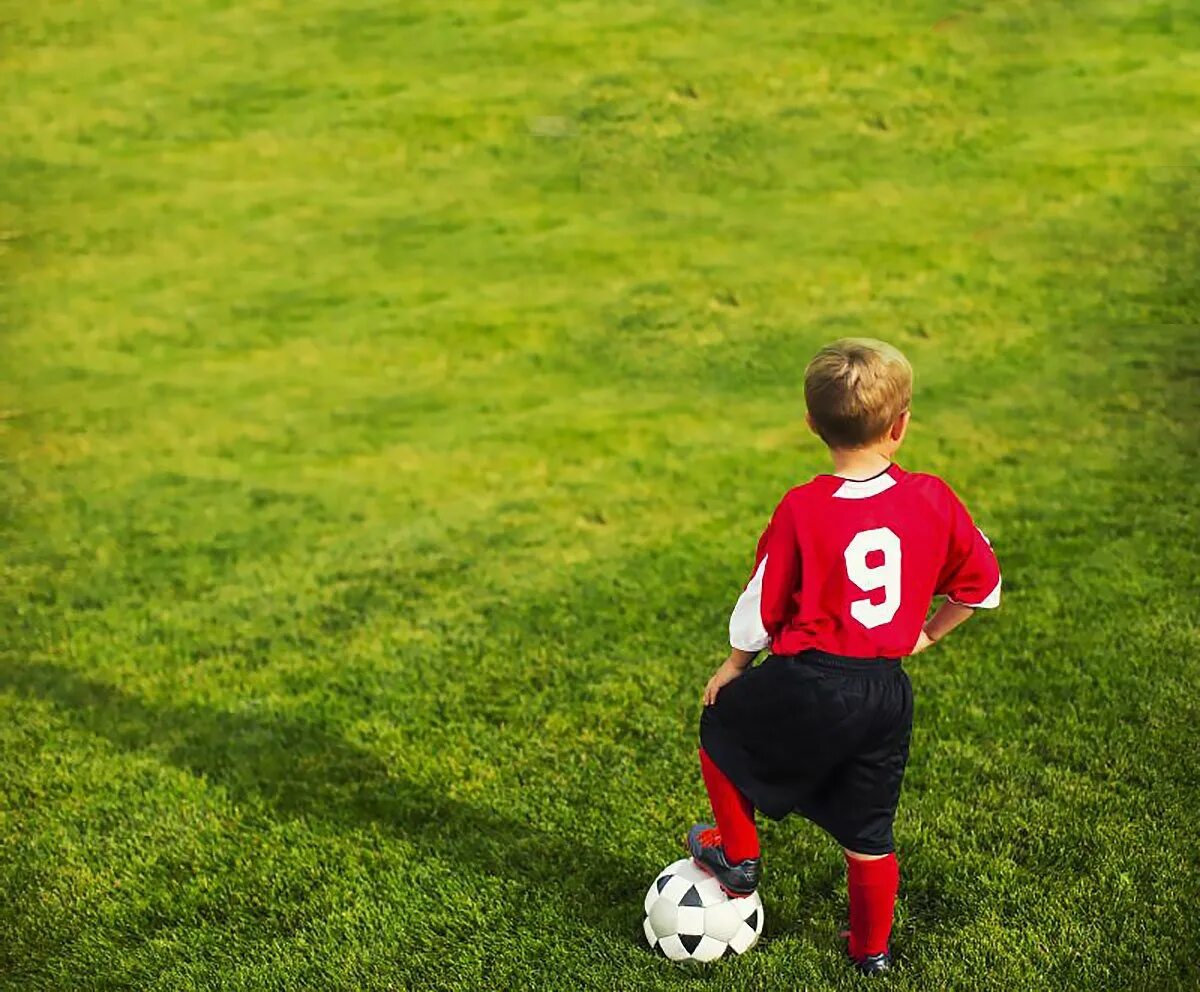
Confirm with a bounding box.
[688,338,1000,974]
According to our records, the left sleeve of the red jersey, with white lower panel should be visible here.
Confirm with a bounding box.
[730,499,800,654]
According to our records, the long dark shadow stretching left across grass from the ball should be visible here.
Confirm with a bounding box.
[0,662,648,913]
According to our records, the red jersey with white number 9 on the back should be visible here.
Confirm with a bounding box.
[730,465,1000,657]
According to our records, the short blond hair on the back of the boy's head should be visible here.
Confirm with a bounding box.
[804,337,912,449]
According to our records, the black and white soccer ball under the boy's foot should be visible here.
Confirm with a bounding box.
[642,858,762,961]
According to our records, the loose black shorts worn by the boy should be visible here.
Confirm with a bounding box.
[700,651,912,854]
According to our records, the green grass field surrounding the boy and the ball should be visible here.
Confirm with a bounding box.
[0,0,1200,992]
